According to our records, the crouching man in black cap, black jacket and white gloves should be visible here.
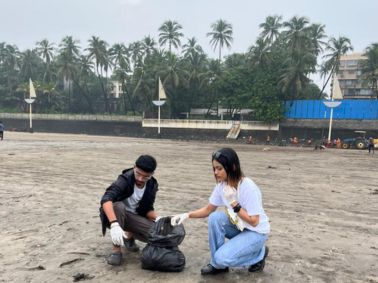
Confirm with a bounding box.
[100,155,158,265]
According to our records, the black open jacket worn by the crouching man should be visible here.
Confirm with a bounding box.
[100,168,158,235]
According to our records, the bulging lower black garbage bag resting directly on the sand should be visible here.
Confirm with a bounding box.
[141,244,185,272]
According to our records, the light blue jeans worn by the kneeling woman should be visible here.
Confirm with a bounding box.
[208,211,268,268]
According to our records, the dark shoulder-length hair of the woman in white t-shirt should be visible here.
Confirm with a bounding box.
[211,147,244,188]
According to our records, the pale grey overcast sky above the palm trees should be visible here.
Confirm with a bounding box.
[0,0,378,85]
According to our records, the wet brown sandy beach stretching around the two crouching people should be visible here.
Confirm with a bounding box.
[0,132,378,283]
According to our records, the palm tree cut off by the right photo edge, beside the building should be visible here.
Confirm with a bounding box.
[362,43,378,98]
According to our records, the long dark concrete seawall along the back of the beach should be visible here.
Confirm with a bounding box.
[2,118,378,143]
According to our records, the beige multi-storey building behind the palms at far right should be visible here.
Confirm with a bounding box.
[337,53,374,99]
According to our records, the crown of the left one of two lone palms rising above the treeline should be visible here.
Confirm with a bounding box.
[159,20,184,52]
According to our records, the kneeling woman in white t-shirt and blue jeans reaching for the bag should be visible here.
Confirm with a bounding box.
[171,148,270,275]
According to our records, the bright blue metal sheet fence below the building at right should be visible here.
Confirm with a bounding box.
[285,99,378,120]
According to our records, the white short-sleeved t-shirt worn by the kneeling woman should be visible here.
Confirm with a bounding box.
[209,177,270,234]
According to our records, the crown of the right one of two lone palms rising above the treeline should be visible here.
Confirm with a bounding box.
[206,19,233,61]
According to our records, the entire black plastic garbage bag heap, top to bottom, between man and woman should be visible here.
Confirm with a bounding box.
[141,217,185,272]
